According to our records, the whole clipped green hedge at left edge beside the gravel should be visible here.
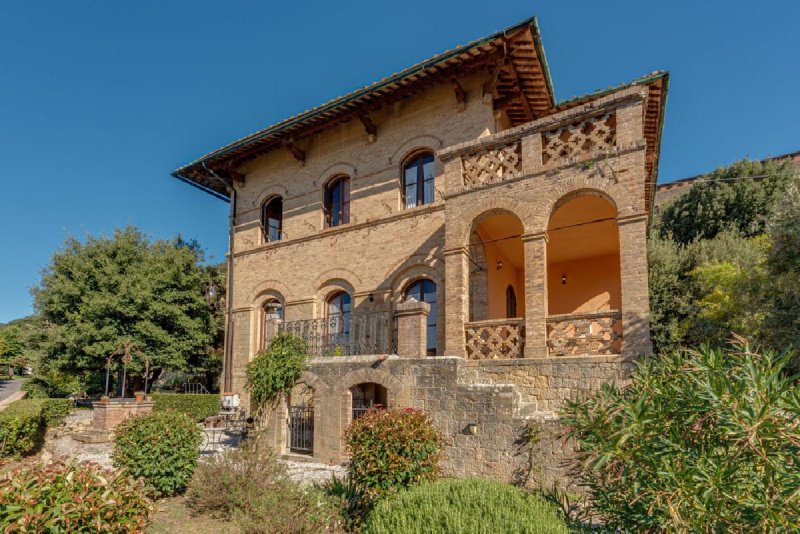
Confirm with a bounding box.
[0,399,72,457]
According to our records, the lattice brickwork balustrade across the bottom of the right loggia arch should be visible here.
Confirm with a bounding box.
[547,310,622,356]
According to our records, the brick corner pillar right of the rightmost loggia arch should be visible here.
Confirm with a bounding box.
[617,213,653,359]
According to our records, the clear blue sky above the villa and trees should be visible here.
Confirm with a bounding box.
[0,0,800,322]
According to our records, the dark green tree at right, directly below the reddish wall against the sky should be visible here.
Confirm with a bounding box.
[659,160,797,245]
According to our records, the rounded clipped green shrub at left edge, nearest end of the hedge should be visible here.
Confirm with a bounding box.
[0,399,45,457]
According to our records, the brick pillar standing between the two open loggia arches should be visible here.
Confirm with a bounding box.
[522,232,547,358]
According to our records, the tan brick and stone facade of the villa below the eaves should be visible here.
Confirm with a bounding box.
[177,16,663,488]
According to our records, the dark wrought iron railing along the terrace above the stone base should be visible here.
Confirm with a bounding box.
[279,312,396,356]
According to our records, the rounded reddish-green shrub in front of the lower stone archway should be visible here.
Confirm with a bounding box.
[345,408,442,498]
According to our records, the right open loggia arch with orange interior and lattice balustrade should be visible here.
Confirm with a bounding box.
[547,192,622,355]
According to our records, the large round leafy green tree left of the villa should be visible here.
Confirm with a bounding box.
[33,227,217,394]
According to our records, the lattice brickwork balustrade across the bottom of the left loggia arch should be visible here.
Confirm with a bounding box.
[464,319,525,360]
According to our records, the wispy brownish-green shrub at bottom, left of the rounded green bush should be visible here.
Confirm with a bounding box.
[187,435,341,533]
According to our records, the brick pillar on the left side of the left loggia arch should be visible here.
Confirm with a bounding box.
[444,247,469,358]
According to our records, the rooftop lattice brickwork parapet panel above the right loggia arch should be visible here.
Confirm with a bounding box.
[542,111,617,168]
